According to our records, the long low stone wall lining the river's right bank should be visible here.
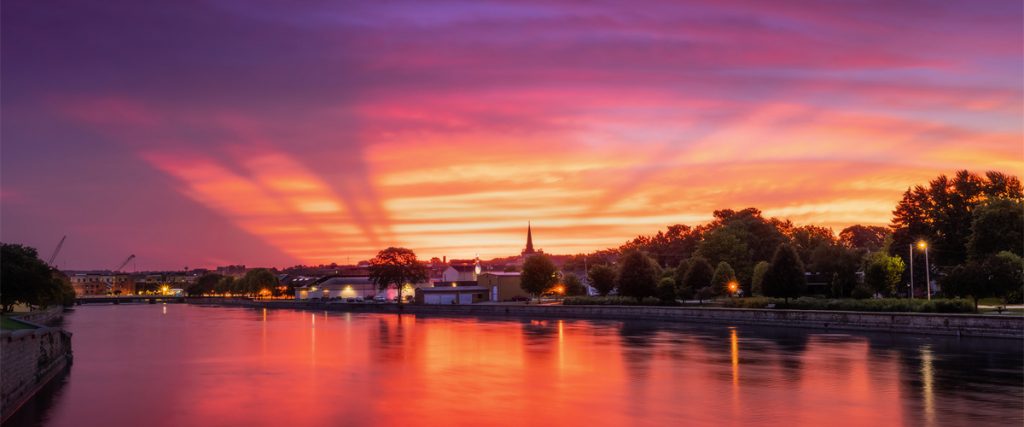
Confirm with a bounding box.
[188,298,1024,340]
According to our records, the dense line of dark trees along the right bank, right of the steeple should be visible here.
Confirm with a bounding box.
[548,167,1024,302]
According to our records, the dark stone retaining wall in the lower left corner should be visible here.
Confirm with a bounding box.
[0,328,72,420]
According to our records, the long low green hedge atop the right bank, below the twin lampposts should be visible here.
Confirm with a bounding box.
[724,297,974,313]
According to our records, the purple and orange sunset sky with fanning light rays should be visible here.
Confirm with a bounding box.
[0,0,1024,270]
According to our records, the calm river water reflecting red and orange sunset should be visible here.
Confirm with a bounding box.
[8,304,1024,427]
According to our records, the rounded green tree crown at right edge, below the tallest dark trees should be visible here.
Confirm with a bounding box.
[967,198,1024,260]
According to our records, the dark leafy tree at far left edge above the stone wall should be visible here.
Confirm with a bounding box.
[0,244,75,312]
